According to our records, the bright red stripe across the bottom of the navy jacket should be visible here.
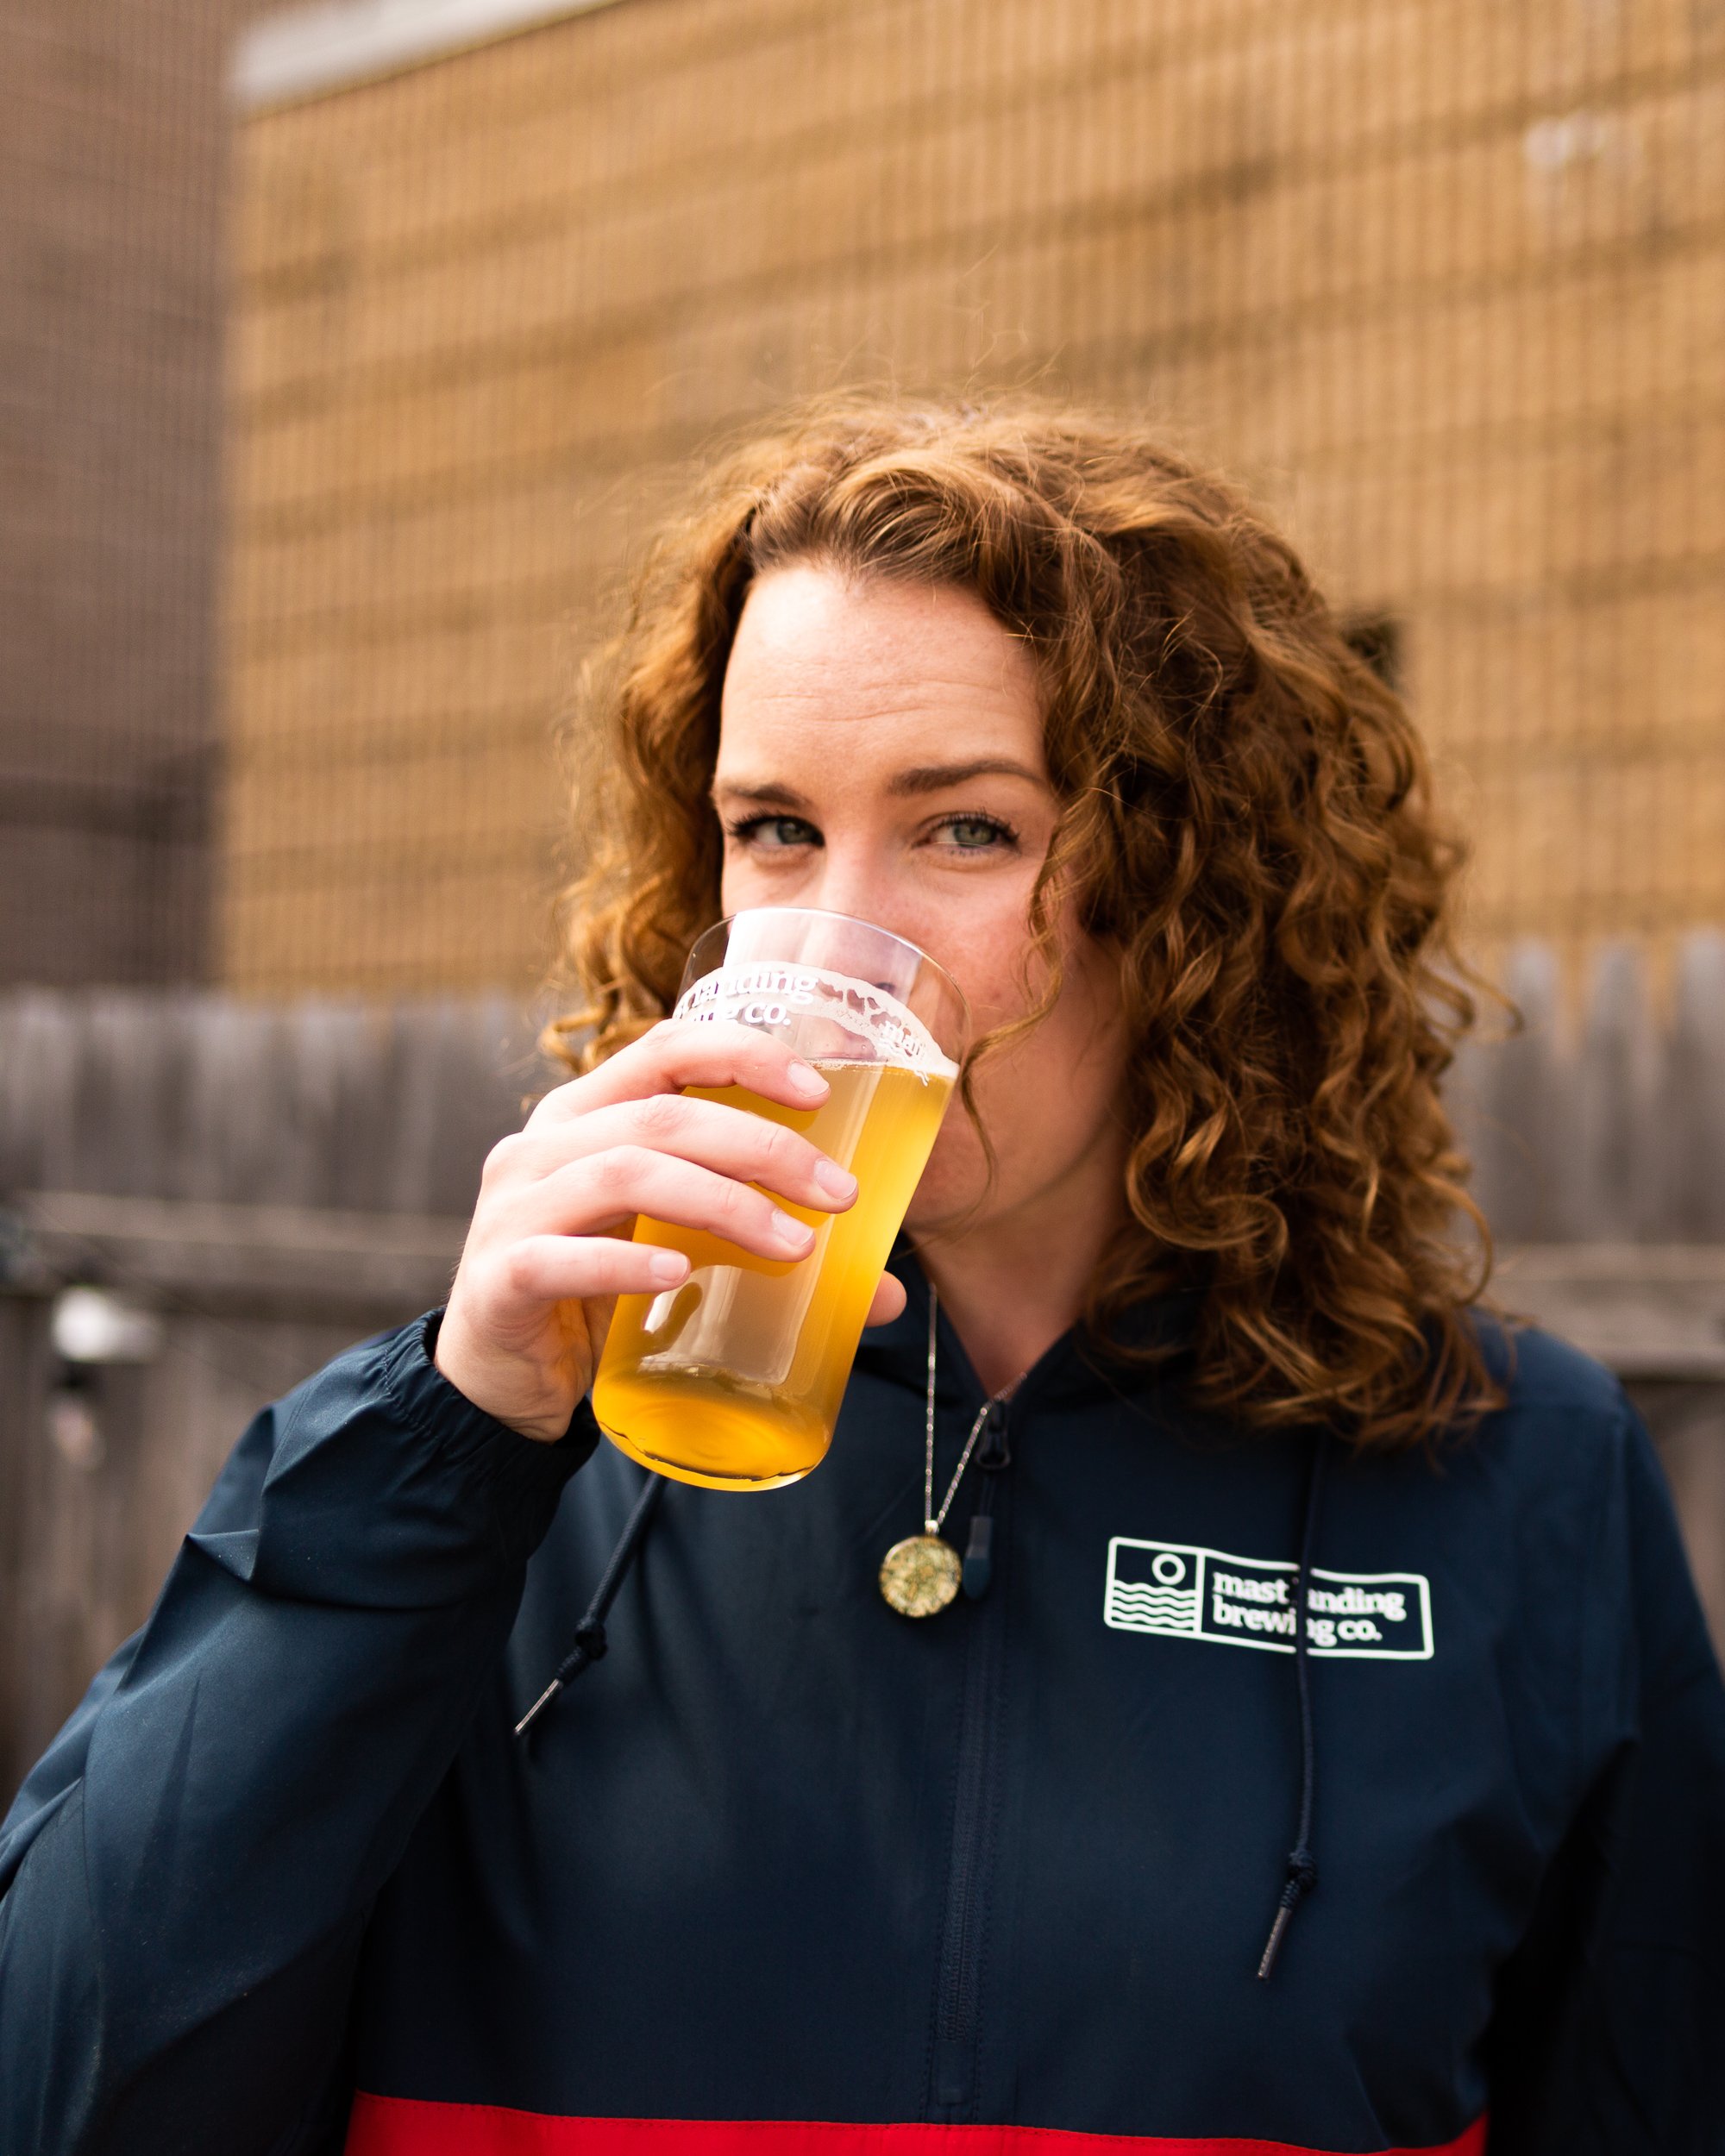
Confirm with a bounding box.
[348,2091,1486,2156]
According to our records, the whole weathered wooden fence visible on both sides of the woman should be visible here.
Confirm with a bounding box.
[0,938,1725,1783]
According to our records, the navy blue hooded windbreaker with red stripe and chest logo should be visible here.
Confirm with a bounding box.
[0,1257,1725,2156]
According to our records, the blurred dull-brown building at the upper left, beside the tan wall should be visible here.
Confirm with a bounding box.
[0,0,276,983]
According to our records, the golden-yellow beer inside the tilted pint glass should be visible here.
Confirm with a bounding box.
[593,1055,957,1490]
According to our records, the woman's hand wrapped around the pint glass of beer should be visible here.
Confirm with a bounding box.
[436,1022,904,1443]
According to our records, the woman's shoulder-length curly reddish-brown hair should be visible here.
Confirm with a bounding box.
[552,399,1501,1445]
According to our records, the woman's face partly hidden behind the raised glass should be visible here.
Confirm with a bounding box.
[714,563,1126,1236]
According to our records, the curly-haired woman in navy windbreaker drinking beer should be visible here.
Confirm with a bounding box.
[0,404,1725,2156]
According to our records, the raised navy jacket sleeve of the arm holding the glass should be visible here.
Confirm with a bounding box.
[0,1313,598,2156]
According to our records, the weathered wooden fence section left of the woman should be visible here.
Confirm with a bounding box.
[0,994,528,1781]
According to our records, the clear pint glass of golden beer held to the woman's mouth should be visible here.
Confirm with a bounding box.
[593,906,969,1490]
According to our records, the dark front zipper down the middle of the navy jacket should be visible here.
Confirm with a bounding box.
[930,1404,1012,2120]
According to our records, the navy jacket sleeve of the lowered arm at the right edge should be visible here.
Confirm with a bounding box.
[1490,1406,1725,2156]
